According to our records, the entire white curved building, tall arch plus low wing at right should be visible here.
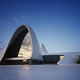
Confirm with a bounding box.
[0,25,80,64]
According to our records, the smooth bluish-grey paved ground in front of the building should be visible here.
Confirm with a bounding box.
[0,64,80,80]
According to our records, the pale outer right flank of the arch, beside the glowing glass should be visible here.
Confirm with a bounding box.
[28,27,43,60]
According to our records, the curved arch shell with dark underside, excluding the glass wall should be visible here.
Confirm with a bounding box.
[0,25,43,61]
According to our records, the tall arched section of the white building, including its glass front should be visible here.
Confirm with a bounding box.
[0,25,43,63]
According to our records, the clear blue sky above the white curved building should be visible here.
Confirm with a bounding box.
[0,0,80,52]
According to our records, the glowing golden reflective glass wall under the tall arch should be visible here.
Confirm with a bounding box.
[18,32,32,58]
